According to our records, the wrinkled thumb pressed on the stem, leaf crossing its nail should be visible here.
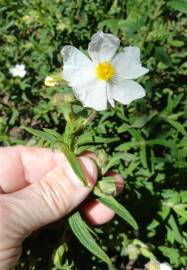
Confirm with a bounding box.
[4,157,97,239]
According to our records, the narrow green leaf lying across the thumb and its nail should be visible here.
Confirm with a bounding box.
[60,143,88,186]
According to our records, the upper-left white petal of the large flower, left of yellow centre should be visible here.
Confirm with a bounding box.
[61,46,95,88]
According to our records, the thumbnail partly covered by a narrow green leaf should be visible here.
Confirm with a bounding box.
[66,157,97,188]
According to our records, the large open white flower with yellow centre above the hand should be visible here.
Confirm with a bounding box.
[61,32,148,111]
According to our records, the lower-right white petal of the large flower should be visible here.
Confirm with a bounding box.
[110,80,145,105]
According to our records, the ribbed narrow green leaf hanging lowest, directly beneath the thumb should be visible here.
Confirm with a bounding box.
[69,212,111,265]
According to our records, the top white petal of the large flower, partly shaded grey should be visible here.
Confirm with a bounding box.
[88,31,120,63]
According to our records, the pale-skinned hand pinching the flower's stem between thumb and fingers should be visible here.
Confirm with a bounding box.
[0,146,123,270]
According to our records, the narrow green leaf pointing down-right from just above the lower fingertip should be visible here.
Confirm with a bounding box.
[97,195,138,230]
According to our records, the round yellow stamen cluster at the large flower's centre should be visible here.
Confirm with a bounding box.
[95,62,116,81]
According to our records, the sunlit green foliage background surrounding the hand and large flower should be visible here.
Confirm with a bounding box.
[0,0,187,270]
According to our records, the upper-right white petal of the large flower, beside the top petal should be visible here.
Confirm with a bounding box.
[112,46,149,79]
